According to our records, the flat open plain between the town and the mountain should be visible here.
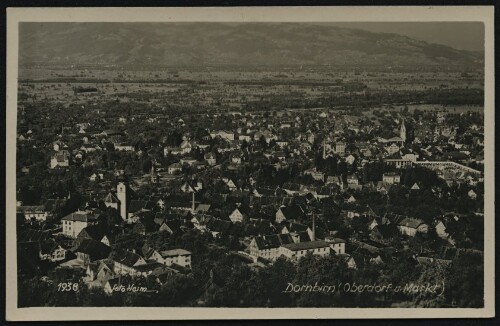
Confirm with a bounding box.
[19,67,483,110]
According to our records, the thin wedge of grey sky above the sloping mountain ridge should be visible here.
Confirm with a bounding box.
[333,22,484,51]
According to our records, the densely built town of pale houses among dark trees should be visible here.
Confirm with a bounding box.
[17,62,484,307]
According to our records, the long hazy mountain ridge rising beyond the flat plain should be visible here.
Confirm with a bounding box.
[19,23,484,66]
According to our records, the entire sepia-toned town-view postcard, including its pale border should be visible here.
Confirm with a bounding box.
[7,8,495,319]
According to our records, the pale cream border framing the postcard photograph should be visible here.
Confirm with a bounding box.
[6,6,495,321]
